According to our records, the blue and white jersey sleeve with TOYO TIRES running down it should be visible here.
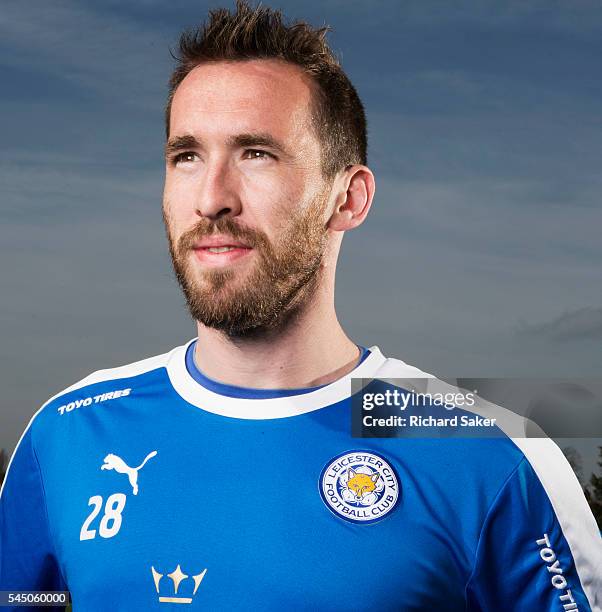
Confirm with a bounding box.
[466,440,602,612]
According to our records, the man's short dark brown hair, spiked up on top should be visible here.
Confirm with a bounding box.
[165,0,367,179]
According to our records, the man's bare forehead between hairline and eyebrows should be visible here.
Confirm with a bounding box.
[170,59,311,138]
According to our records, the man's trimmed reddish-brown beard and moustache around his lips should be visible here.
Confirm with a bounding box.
[163,192,328,338]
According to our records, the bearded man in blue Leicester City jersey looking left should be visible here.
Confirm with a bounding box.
[0,2,601,610]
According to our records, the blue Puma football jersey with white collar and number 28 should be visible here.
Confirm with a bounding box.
[0,340,602,612]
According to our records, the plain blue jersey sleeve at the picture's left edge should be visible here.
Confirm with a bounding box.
[0,426,67,610]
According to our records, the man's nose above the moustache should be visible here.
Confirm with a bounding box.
[195,160,241,220]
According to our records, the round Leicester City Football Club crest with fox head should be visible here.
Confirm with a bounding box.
[320,451,400,523]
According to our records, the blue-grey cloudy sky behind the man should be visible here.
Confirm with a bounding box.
[0,0,602,476]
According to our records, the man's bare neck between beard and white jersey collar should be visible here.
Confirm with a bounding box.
[195,278,360,389]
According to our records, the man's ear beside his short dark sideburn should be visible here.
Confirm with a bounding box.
[327,165,375,232]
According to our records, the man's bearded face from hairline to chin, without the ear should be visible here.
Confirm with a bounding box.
[163,60,330,336]
